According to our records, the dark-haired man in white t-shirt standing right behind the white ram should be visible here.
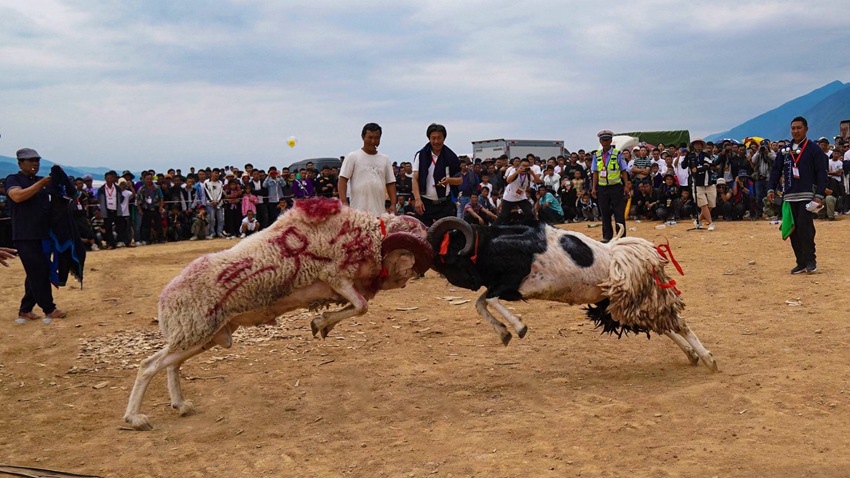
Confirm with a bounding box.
[337,123,396,217]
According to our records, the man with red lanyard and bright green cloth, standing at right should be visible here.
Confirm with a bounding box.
[767,116,827,274]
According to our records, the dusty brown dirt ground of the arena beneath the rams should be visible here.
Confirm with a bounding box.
[0,219,850,477]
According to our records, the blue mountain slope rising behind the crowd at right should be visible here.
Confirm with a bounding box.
[705,81,850,141]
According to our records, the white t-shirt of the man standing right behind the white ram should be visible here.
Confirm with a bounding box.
[339,149,395,217]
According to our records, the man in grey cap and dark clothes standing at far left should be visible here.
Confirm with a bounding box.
[6,148,67,324]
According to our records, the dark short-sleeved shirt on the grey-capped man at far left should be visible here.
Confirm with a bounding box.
[6,172,50,241]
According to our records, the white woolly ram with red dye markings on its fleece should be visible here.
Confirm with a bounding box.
[124,199,433,430]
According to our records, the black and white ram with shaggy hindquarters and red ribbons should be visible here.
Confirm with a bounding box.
[428,217,717,371]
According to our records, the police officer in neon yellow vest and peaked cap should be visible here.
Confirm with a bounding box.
[590,129,632,242]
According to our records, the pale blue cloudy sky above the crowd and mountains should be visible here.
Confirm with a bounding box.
[0,0,850,171]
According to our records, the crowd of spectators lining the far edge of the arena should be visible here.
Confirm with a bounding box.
[0,138,850,250]
